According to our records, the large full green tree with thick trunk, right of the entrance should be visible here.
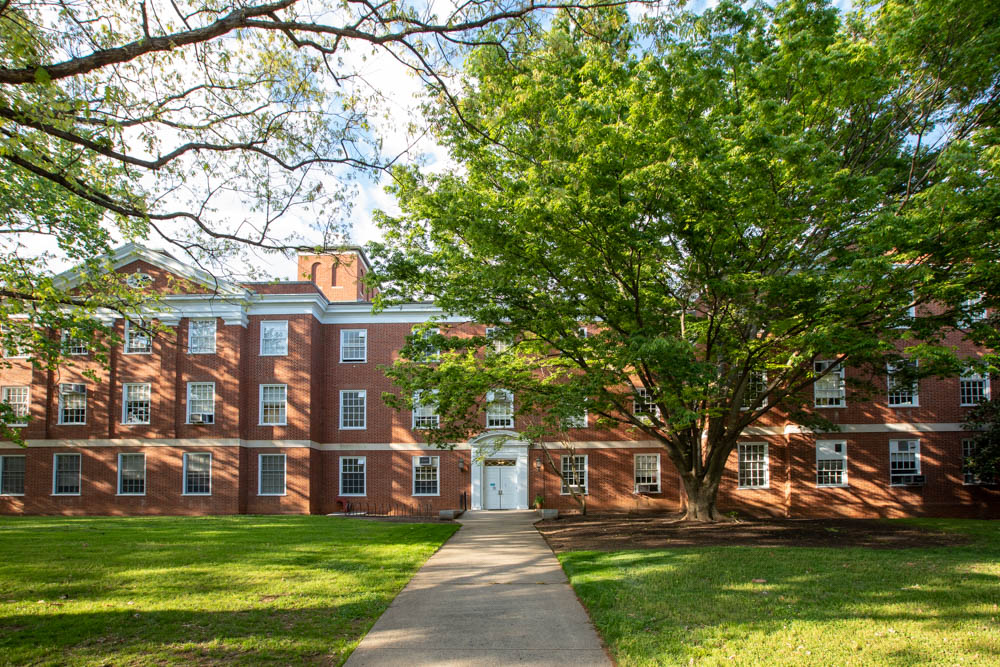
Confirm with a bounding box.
[372,0,1000,520]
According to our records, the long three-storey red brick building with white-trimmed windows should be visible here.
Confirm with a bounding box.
[0,245,1000,517]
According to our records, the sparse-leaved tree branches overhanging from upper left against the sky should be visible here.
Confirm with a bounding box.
[0,0,640,436]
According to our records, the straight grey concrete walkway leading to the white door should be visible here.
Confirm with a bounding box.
[347,511,611,667]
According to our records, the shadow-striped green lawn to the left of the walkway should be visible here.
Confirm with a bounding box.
[0,516,457,665]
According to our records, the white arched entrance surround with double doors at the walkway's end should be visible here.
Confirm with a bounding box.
[469,431,531,510]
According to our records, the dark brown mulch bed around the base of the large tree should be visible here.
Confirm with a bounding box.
[535,514,969,553]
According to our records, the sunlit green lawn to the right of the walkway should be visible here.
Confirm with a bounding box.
[560,519,1000,666]
